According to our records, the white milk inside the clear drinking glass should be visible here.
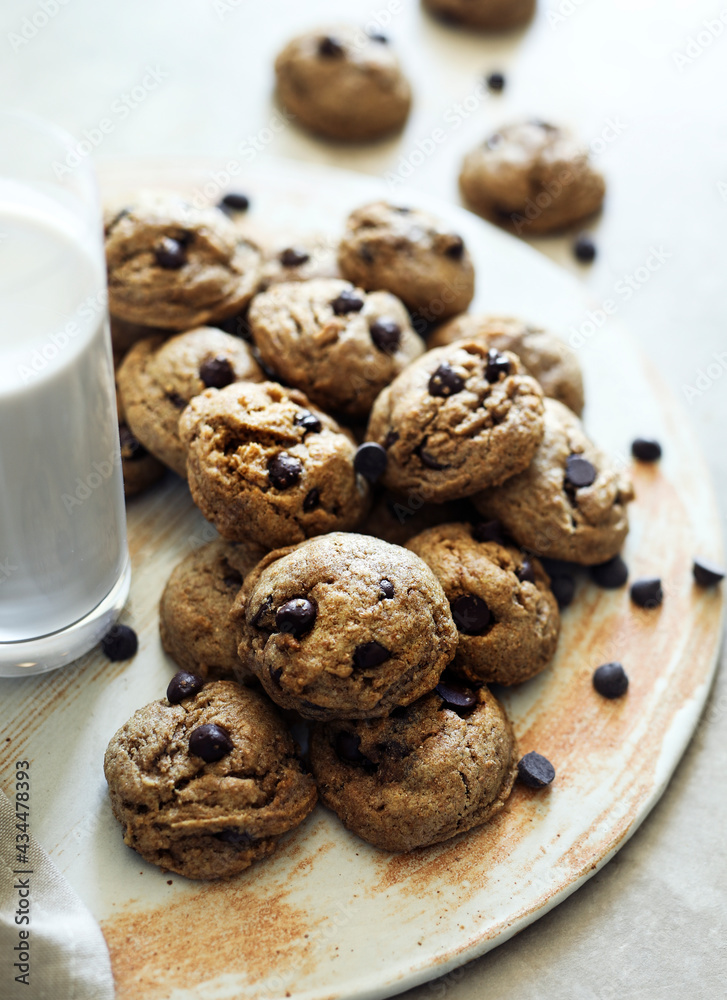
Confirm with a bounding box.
[0,180,126,643]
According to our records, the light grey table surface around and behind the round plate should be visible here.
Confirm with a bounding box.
[0,0,727,1000]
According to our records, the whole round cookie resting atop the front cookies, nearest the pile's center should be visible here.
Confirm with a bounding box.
[231,532,457,719]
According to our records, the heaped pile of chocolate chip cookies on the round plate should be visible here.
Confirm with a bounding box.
[105,184,633,878]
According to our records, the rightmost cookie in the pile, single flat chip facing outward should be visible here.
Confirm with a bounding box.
[473,399,634,566]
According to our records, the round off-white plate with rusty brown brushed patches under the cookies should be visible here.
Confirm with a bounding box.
[0,158,722,1000]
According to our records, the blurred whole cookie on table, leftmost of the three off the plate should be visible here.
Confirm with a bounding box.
[275,25,411,142]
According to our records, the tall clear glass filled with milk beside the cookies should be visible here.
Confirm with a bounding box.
[0,114,130,676]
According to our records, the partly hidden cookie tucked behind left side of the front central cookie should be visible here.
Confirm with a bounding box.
[159,539,266,680]
